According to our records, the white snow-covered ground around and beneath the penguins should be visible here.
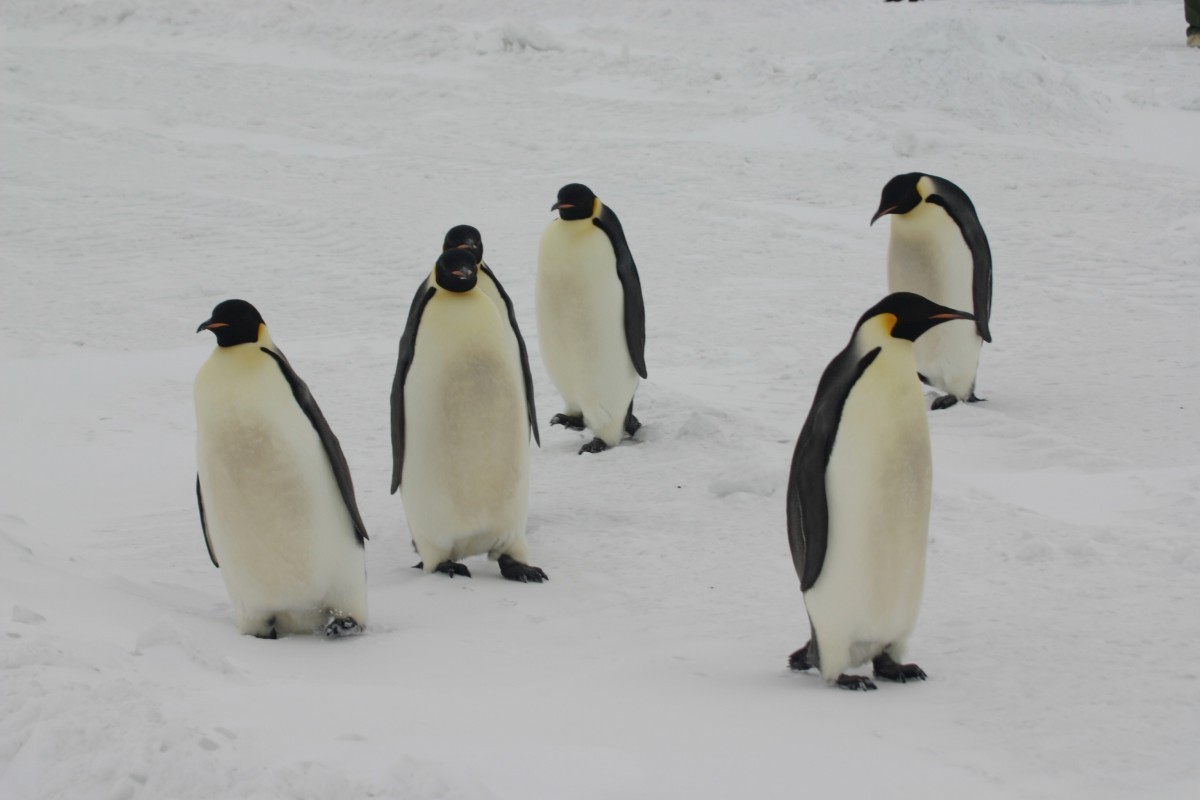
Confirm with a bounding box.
[0,0,1200,800]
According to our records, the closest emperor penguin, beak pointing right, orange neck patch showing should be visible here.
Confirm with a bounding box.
[787,291,971,690]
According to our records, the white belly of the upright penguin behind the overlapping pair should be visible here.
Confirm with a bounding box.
[536,219,637,446]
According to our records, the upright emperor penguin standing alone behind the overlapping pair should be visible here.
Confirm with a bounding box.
[536,184,646,453]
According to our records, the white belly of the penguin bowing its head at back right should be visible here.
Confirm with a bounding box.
[888,217,983,399]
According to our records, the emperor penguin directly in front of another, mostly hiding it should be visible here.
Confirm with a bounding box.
[391,247,547,583]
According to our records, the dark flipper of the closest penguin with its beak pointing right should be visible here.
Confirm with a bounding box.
[787,344,880,591]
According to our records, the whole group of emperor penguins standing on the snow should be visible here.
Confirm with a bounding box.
[194,173,991,690]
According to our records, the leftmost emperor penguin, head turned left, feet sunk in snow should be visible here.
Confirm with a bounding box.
[194,300,367,639]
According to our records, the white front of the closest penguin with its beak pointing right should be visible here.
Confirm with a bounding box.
[804,354,931,680]
